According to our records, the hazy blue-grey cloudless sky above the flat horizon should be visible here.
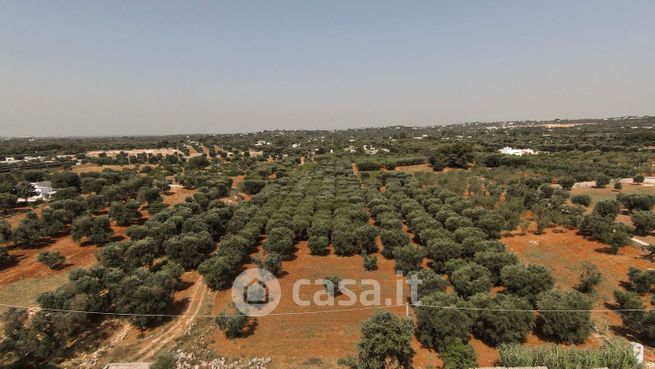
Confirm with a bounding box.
[0,0,655,136]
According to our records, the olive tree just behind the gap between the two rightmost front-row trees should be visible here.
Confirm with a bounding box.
[500,264,555,304]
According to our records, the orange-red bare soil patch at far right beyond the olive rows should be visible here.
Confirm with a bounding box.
[502,229,655,360]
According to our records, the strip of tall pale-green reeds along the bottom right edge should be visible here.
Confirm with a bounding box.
[500,338,639,369]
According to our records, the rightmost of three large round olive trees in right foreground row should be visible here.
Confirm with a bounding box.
[537,291,592,343]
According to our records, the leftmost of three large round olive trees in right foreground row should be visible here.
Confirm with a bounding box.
[416,292,473,350]
